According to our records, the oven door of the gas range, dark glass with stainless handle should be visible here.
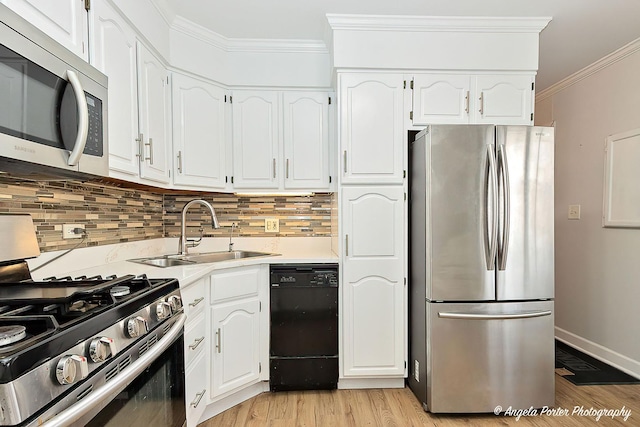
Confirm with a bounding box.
[37,314,186,427]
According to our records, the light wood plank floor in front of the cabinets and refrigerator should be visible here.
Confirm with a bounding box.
[199,376,640,427]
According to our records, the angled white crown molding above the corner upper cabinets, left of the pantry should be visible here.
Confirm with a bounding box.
[171,16,329,54]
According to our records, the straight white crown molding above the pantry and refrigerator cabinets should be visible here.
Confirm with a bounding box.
[326,13,551,33]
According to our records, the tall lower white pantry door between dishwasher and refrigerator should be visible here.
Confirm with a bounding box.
[341,187,406,377]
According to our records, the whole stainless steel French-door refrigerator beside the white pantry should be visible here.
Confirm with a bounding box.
[409,125,555,413]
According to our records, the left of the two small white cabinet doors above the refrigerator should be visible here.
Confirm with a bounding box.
[413,74,471,125]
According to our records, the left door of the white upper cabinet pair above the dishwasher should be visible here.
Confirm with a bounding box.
[231,91,282,189]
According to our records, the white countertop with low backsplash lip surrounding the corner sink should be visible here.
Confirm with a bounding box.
[29,237,338,287]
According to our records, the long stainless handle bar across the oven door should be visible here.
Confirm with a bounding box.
[40,314,187,427]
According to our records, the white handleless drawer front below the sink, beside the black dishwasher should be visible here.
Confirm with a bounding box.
[211,266,262,304]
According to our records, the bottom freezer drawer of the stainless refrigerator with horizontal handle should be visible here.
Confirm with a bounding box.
[425,301,555,412]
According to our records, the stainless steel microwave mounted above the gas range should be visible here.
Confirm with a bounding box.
[0,4,109,176]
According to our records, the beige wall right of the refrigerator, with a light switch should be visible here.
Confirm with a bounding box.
[536,39,640,377]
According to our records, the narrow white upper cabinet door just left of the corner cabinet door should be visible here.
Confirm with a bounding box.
[137,42,171,183]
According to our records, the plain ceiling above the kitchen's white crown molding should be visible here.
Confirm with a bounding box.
[156,0,640,90]
